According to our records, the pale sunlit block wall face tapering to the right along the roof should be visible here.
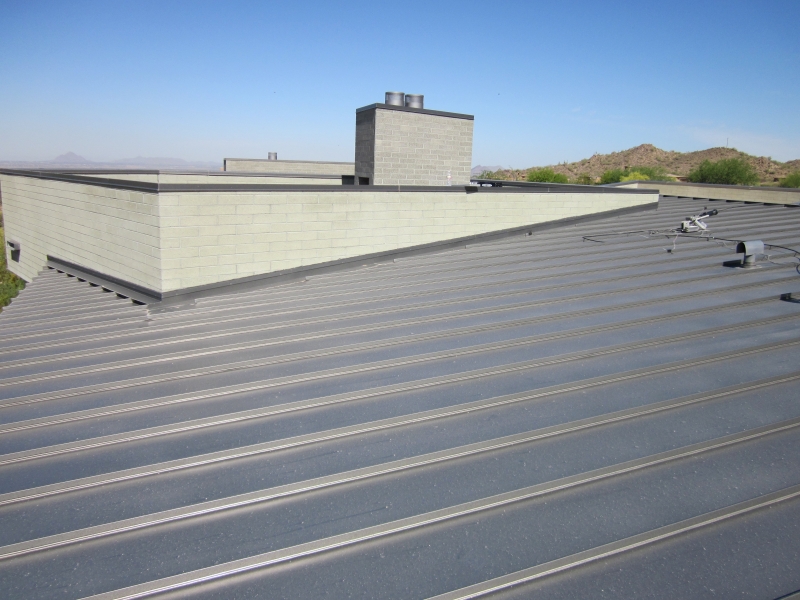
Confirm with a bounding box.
[156,188,658,291]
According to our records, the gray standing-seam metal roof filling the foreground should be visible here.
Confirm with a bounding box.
[0,199,800,599]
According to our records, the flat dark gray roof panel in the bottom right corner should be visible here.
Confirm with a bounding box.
[492,499,800,600]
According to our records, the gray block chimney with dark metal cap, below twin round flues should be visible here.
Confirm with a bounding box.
[355,104,474,186]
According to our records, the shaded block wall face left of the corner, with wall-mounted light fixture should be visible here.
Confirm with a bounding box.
[0,175,161,289]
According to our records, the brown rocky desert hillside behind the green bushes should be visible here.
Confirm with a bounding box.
[484,144,800,184]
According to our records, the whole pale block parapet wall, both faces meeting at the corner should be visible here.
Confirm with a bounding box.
[0,171,658,298]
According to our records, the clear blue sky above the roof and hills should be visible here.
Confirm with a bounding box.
[0,0,800,167]
